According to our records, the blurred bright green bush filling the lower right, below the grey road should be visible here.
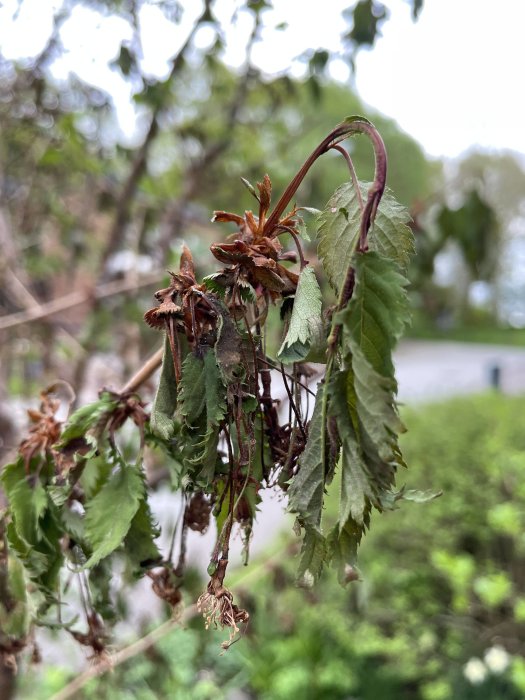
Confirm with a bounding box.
[19,395,525,700]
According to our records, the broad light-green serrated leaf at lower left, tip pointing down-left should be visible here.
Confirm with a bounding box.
[85,460,144,568]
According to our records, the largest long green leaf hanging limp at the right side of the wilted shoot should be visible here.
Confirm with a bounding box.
[327,252,408,549]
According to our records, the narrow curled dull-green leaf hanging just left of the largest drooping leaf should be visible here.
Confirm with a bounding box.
[288,384,326,528]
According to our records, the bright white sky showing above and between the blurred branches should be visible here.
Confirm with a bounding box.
[0,0,525,157]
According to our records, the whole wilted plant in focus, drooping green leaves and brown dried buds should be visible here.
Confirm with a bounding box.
[0,117,426,653]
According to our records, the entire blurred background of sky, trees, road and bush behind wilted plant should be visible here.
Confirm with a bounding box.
[0,0,525,700]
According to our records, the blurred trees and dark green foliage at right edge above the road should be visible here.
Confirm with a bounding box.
[411,151,525,331]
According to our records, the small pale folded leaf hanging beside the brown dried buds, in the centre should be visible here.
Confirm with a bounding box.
[277,265,323,363]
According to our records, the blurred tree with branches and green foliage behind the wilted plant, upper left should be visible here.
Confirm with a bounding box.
[0,0,433,410]
